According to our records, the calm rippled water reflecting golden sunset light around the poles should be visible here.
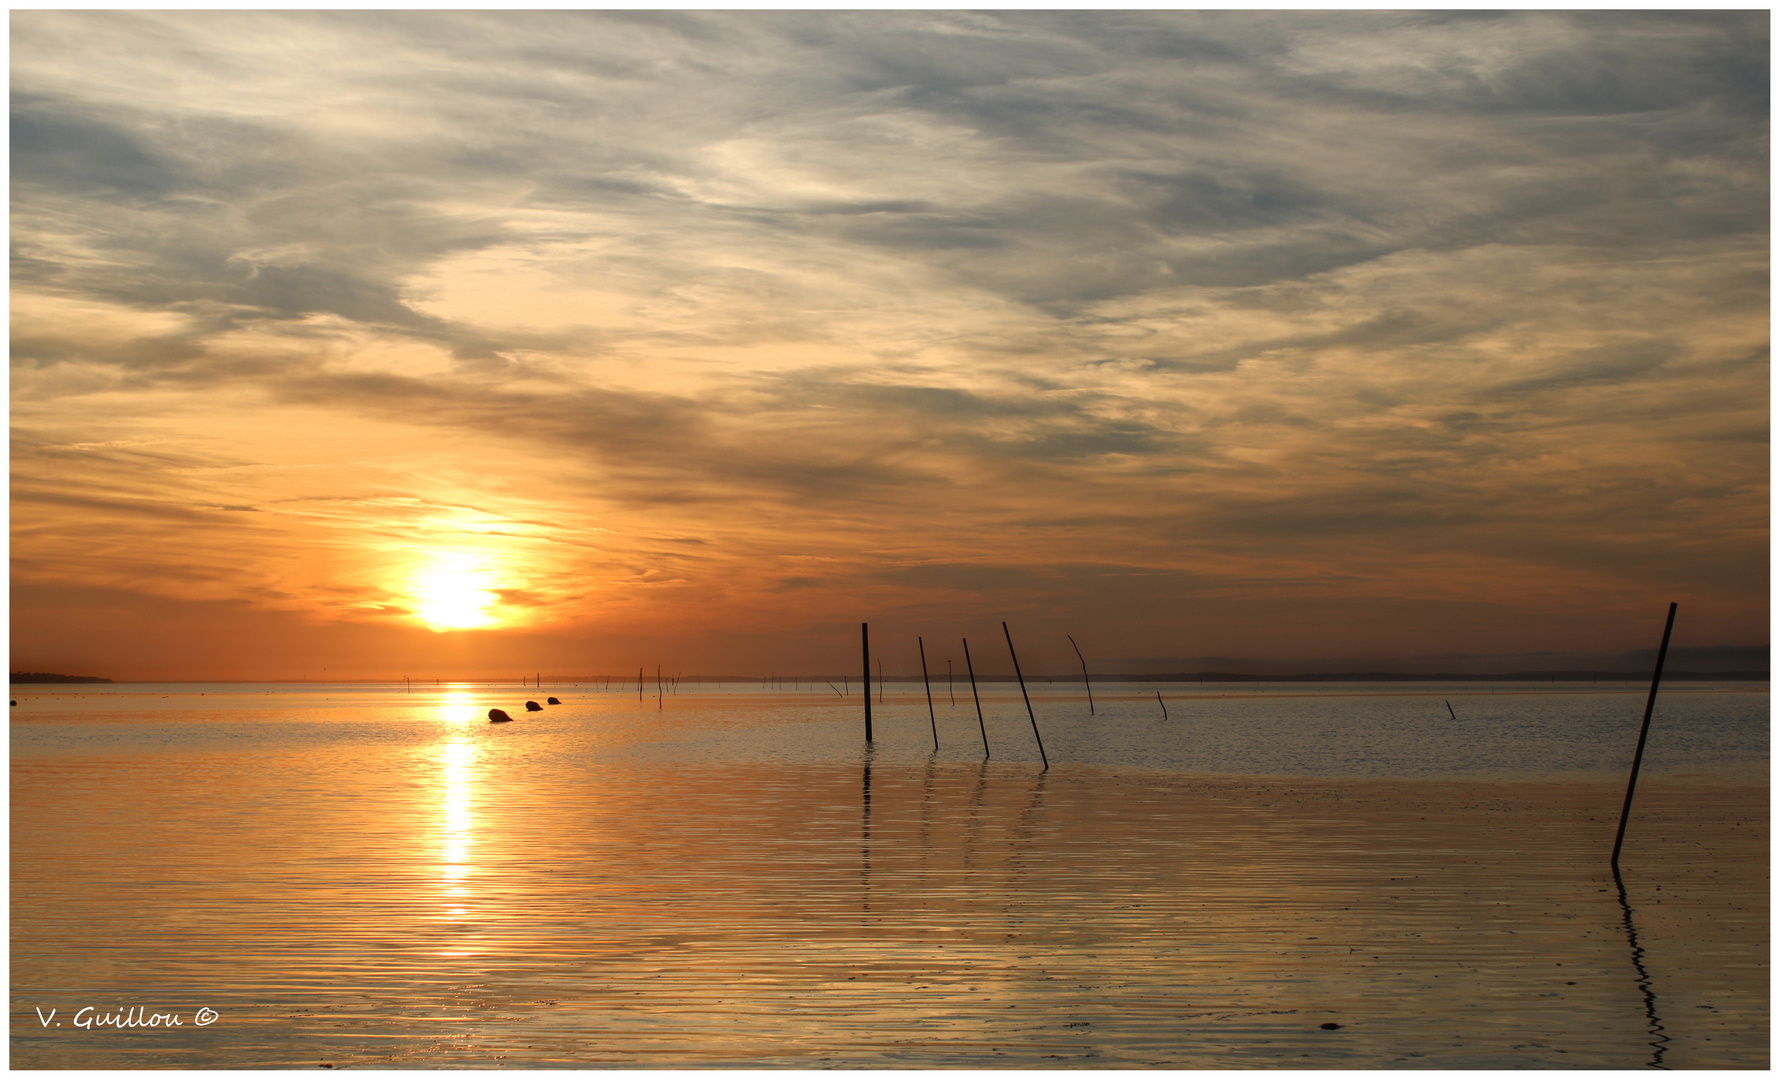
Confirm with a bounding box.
[12,683,1768,1068]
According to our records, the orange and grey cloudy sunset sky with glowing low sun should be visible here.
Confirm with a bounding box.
[11,11,1769,680]
